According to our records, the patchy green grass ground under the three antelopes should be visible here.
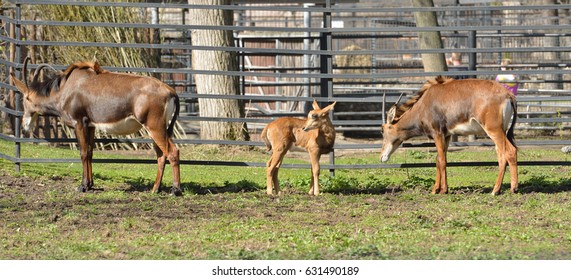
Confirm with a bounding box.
[0,141,571,260]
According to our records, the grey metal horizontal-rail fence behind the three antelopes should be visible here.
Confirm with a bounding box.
[0,0,571,173]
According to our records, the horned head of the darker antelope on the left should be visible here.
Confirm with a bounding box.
[10,57,55,133]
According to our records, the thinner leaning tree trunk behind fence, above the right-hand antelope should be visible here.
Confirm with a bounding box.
[412,0,448,72]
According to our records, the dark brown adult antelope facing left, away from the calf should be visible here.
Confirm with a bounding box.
[11,58,182,195]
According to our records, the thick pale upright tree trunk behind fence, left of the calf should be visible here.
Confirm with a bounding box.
[188,0,249,140]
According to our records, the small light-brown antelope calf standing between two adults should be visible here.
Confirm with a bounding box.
[262,100,337,195]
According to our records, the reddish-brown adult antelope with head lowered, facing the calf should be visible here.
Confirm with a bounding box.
[381,77,518,194]
